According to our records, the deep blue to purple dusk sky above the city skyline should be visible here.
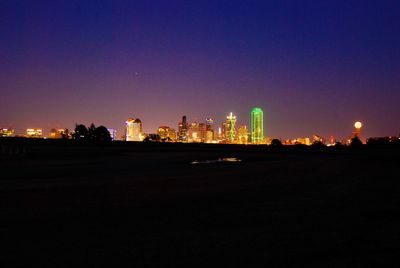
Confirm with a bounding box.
[0,0,400,138]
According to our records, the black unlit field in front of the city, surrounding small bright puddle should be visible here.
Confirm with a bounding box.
[0,140,400,267]
